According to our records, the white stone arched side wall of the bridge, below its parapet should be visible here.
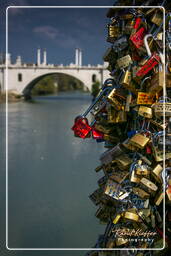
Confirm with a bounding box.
[3,65,109,94]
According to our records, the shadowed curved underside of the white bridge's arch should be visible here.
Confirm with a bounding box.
[22,71,89,96]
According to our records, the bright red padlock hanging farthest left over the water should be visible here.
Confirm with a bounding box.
[71,116,92,139]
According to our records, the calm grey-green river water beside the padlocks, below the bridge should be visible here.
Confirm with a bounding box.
[1,92,104,256]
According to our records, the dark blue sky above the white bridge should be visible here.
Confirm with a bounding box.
[0,0,117,65]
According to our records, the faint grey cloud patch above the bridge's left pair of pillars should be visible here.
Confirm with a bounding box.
[33,26,59,39]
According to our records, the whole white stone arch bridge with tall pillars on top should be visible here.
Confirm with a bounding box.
[0,48,109,95]
